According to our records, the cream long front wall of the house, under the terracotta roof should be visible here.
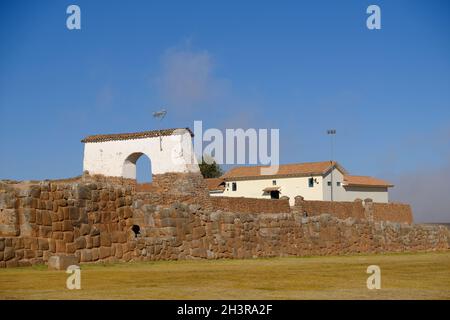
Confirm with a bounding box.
[221,176,323,205]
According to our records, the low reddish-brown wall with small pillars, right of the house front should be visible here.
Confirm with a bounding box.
[294,196,413,224]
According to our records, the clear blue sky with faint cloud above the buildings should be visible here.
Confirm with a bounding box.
[0,0,450,221]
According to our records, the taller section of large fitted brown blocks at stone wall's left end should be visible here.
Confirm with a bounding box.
[0,180,133,266]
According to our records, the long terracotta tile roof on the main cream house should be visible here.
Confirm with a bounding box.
[222,161,347,180]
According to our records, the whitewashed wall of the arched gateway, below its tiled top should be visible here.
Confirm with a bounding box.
[83,130,200,179]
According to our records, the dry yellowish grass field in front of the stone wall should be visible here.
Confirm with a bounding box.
[0,252,450,299]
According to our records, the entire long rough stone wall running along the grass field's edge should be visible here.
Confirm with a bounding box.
[0,174,450,267]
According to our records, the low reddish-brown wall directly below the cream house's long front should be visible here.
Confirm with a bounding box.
[211,197,291,213]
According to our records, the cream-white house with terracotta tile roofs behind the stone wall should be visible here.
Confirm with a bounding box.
[207,161,393,205]
